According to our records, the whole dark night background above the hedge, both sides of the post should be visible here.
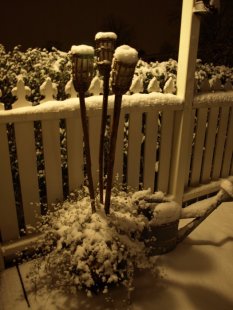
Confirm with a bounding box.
[0,0,233,65]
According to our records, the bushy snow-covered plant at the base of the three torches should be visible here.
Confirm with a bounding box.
[30,188,156,295]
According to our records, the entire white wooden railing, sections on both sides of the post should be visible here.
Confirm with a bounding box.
[0,83,233,246]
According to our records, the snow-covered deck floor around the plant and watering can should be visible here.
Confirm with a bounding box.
[0,202,233,310]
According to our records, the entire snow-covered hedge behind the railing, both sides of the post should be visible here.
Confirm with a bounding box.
[0,45,233,107]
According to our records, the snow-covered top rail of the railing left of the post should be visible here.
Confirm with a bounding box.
[0,93,183,124]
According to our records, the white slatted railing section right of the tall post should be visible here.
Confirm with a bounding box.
[183,91,233,201]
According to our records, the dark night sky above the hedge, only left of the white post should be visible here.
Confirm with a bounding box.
[0,0,182,54]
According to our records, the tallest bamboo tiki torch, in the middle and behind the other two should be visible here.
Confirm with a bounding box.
[95,32,117,203]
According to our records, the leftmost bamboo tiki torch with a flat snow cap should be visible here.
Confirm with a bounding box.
[71,45,96,213]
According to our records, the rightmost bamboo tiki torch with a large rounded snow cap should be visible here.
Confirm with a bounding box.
[104,45,138,214]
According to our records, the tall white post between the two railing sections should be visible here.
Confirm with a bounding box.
[169,0,200,204]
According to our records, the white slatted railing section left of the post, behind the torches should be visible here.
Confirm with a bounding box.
[0,85,185,241]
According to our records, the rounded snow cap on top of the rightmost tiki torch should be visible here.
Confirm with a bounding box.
[114,45,138,65]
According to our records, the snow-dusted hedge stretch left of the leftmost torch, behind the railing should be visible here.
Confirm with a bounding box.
[0,45,71,108]
